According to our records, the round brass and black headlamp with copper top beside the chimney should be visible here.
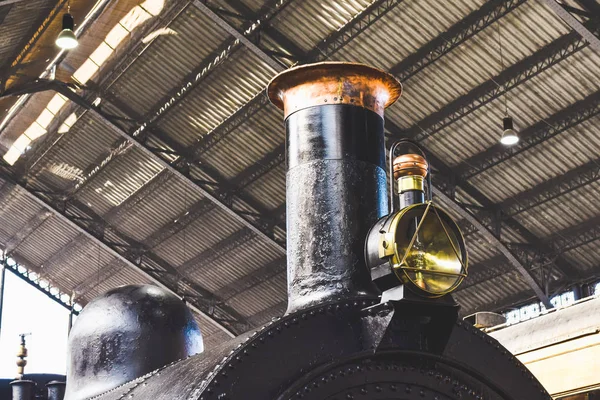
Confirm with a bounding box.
[367,141,468,297]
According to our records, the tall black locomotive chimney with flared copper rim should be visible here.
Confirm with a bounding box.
[268,63,402,313]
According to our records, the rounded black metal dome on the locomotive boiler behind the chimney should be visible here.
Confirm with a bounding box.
[66,285,203,400]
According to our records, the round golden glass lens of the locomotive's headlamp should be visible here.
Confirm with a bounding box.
[396,204,466,295]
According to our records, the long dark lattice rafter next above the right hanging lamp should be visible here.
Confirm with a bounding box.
[398,27,588,141]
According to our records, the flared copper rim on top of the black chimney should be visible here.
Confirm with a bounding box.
[267,62,402,118]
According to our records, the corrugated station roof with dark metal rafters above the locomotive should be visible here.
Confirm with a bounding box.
[0,0,600,345]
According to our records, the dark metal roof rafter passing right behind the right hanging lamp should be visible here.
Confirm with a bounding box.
[456,91,600,179]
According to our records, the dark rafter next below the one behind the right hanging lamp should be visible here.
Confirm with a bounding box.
[500,158,600,217]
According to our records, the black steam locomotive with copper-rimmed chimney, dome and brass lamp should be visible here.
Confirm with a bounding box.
[12,63,550,400]
